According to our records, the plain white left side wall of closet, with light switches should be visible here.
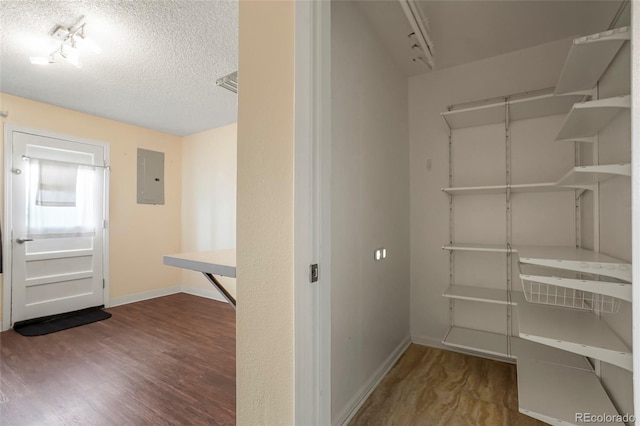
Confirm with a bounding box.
[331,2,410,424]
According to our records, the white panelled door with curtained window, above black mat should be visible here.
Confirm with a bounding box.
[6,129,107,324]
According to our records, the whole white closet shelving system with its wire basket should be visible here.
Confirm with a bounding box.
[442,27,632,424]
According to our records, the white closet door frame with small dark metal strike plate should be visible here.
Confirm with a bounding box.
[294,1,331,425]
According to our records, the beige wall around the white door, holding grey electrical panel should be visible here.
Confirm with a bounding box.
[0,93,181,318]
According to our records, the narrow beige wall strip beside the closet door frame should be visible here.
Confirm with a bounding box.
[236,1,295,426]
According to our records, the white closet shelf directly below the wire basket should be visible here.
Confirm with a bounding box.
[517,303,632,371]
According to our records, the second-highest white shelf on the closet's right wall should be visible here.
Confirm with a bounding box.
[556,95,631,142]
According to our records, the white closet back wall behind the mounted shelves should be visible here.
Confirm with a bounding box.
[409,40,572,346]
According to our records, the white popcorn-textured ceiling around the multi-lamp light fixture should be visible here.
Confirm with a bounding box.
[0,0,238,136]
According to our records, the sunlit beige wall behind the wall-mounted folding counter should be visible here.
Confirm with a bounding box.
[181,123,238,295]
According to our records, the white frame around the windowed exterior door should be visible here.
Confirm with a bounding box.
[1,123,111,331]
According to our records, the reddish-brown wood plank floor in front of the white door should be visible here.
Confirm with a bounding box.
[0,293,236,426]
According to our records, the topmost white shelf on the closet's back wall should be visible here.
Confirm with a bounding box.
[441,93,584,129]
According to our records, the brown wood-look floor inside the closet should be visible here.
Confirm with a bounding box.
[349,344,544,426]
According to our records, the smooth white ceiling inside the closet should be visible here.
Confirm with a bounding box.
[358,0,622,75]
